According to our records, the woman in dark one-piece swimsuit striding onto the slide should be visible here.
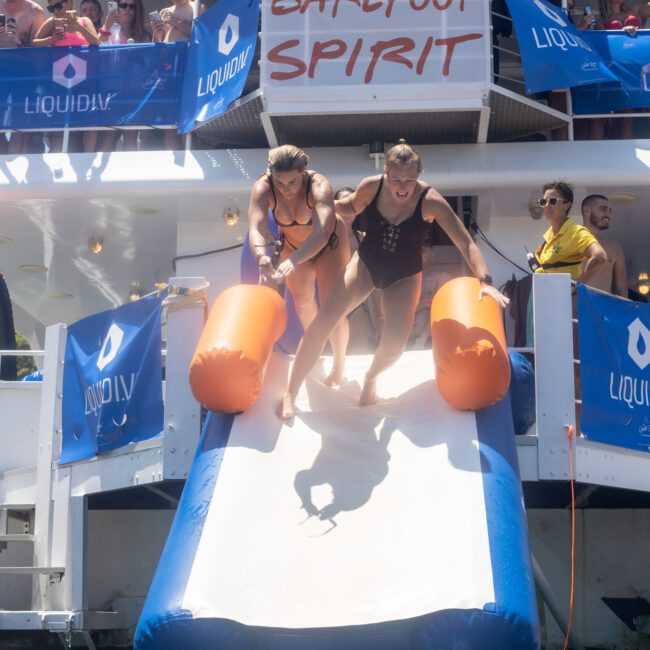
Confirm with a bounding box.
[278,141,508,419]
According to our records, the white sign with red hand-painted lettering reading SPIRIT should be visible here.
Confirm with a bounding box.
[262,0,491,88]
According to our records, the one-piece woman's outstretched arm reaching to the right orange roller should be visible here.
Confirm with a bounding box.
[422,188,510,307]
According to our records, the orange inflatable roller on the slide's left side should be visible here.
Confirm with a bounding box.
[190,284,287,413]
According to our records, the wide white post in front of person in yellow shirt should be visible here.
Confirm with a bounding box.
[533,273,575,480]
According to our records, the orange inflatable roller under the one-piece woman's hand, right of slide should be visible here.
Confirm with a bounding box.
[431,278,510,411]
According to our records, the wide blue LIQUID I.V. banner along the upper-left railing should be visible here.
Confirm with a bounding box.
[0,43,187,129]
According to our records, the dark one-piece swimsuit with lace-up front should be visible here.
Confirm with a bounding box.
[359,176,431,289]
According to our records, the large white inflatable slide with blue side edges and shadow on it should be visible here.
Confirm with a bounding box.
[135,284,539,650]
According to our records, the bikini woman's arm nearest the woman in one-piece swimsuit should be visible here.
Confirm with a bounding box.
[273,174,336,279]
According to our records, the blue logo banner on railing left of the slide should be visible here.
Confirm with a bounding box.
[59,295,164,463]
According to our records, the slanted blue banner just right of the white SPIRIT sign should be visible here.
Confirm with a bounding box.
[507,0,617,94]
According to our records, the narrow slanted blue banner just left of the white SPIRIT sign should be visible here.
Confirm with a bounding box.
[179,0,260,133]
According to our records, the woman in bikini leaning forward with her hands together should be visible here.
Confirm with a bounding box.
[248,145,350,385]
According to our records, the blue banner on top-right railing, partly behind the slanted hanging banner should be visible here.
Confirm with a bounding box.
[571,30,650,115]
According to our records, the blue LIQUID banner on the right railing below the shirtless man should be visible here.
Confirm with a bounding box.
[578,285,650,452]
